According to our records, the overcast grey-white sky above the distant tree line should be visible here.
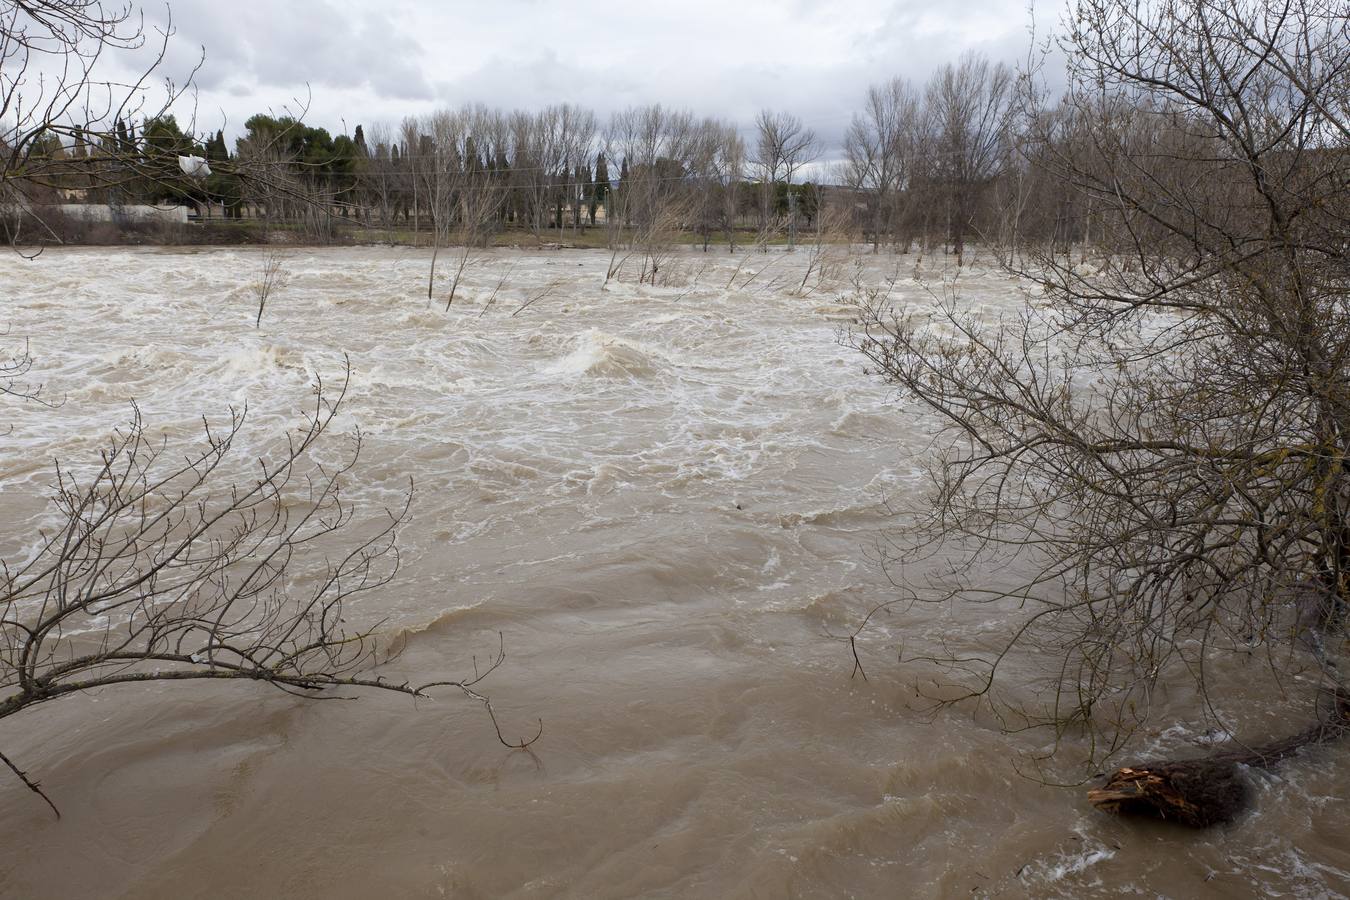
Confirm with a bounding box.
[134,0,1042,155]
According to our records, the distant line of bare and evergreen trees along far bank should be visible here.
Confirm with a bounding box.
[10,43,1306,259]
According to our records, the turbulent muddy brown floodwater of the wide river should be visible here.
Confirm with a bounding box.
[0,248,1350,899]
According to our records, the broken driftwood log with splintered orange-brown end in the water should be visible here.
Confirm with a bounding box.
[1088,694,1350,828]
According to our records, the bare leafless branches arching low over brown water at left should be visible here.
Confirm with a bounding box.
[0,367,537,815]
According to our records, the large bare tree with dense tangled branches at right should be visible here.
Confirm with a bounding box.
[857,0,1350,777]
